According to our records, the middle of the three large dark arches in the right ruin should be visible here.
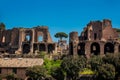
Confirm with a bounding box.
[90,42,100,55]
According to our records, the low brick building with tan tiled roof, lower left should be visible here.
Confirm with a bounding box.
[0,58,43,80]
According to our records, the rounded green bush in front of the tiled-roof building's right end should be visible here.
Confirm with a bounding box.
[26,66,47,80]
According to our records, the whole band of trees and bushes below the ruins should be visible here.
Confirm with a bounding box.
[25,54,120,80]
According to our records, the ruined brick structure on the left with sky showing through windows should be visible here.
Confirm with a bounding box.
[0,26,56,54]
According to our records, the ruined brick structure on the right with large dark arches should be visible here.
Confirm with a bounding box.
[69,19,120,57]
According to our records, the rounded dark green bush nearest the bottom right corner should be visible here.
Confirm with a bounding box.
[97,64,115,80]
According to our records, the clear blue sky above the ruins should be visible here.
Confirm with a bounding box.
[0,0,120,41]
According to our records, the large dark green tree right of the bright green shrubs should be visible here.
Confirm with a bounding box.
[61,56,86,80]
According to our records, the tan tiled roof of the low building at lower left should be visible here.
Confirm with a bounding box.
[0,58,43,68]
